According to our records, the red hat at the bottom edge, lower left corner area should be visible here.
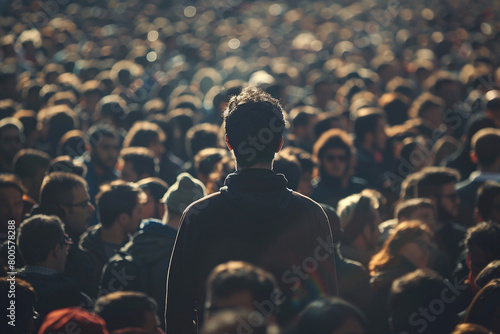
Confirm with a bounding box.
[38,307,108,334]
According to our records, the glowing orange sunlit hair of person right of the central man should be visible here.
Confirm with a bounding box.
[368,220,432,275]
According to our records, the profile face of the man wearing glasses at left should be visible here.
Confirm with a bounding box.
[62,186,95,238]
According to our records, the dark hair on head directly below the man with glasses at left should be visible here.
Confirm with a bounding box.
[17,215,64,265]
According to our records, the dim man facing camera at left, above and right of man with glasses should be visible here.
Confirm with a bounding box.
[80,124,120,225]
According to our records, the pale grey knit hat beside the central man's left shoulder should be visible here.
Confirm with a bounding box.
[161,173,207,214]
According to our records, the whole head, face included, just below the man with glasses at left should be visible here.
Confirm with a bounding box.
[17,215,71,273]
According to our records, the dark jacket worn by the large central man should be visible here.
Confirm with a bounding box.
[166,169,337,334]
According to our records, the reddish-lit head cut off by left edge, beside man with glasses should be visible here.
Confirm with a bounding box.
[0,174,26,228]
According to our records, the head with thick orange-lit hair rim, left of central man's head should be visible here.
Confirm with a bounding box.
[123,121,166,159]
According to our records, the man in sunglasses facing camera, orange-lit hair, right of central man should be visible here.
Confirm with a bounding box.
[311,129,367,208]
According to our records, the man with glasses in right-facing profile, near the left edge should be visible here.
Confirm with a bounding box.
[34,172,95,295]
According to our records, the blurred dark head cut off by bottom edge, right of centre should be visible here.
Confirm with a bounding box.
[296,297,368,334]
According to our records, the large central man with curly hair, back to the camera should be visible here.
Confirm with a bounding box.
[166,87,337,334]
